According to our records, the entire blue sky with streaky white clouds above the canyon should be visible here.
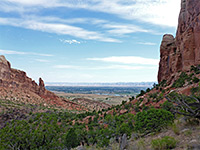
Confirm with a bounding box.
[0,0,180,82]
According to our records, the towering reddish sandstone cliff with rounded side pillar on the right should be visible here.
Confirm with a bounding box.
[158,0,200,83]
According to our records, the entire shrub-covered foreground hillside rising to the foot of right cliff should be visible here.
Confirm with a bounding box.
[0,67,200,150]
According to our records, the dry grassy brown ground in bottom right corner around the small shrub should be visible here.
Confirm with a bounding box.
[127,120,200,150]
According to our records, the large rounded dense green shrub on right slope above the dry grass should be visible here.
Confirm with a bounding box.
[134,108,174,134]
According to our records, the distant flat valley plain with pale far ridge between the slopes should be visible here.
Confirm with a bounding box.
[46,82,153,105]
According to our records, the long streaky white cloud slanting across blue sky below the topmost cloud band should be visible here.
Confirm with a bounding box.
[0,15,150,40]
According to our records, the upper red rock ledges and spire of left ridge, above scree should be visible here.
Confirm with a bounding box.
[0,55,59,99]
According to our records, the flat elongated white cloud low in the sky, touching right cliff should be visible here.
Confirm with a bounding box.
[87,56,159,65]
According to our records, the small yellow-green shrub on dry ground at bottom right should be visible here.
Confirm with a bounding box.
[151,136,177,150]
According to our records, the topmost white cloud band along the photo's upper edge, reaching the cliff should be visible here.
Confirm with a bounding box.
[0,0,181,27]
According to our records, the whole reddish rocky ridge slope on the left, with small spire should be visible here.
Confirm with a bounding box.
[0,55,87,110]
